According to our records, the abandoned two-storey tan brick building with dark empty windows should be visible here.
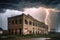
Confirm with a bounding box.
[8,14,48,35]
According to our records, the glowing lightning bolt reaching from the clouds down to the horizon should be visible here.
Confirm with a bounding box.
[44,8,60,31]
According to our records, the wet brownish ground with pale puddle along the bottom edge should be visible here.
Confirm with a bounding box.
[1,36,50,40]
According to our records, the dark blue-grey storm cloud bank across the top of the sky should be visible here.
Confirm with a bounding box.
[0,0,60,12]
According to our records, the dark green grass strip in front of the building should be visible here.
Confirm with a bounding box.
[0,34,60,40]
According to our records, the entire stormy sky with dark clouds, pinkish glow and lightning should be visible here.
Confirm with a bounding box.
[0,0,60,31]
